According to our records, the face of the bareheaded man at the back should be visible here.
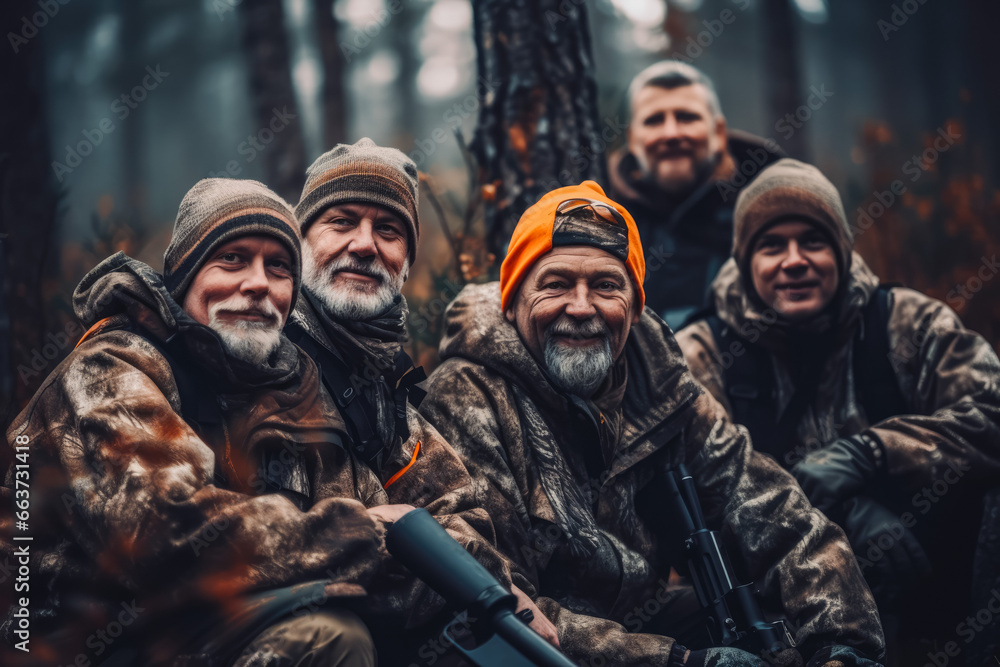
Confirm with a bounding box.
[628,84,726,196]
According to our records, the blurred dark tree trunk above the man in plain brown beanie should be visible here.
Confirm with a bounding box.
[764,0,809,160]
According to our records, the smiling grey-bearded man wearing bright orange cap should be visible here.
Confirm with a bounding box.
[420,181,883,667]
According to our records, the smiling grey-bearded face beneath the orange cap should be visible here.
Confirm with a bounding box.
[504,246,639,396]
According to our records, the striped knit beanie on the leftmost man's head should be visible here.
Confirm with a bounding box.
[163,178,302,309]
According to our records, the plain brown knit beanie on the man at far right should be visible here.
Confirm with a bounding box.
[733,158,854,280]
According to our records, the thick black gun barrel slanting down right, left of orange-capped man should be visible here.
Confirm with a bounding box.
[385,509,574,667]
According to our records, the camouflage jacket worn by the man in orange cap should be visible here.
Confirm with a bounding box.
[421,283,882,665]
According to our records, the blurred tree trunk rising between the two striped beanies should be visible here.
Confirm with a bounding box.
[240,0,306,201]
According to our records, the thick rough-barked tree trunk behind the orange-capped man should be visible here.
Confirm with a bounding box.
[472,0,607,257]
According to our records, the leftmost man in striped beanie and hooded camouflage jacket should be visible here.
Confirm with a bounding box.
[0,179,384,667]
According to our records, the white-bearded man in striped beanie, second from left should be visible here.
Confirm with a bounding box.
[285,138,558,664]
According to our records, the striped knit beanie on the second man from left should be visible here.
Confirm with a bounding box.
[295,137,420,264]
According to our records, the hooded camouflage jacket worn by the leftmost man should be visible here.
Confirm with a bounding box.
[3,253,502,665]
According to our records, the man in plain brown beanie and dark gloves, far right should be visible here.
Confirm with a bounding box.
[677,159,1000,665]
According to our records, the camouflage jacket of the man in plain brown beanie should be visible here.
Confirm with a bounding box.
[677,253,1000,491]
